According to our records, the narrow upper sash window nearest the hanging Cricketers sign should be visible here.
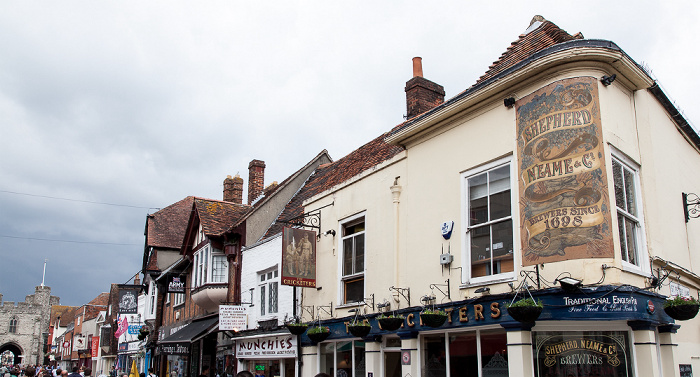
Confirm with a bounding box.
[341,216,365,304]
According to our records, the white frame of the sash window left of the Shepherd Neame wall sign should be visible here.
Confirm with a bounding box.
[460,156,520,286]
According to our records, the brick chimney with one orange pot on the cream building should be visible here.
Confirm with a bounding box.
[405,57,445,119]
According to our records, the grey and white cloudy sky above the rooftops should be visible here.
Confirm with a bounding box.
[0,0,700,305]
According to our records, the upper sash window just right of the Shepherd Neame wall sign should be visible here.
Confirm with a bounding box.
[612,156,642,267]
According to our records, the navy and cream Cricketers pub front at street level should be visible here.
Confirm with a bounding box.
[301,286,678,377]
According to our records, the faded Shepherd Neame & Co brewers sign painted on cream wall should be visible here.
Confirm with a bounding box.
[516,77,613,266]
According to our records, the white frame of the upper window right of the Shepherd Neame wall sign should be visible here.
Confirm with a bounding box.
[610,148,650,275]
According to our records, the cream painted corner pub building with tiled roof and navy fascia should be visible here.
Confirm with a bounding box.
[288,17,700,377]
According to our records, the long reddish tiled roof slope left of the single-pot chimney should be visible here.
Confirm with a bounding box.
[263,134,404,239]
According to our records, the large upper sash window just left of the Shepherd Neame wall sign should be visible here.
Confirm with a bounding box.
[463,160,514,282]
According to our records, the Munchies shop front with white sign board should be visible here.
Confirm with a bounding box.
[235,333,298,377]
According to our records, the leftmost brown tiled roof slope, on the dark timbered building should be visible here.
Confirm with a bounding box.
[146,196,194,250]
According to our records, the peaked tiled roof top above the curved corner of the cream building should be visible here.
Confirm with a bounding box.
[476,16,583,85]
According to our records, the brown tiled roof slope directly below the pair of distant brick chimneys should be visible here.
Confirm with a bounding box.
[194,198,251,235]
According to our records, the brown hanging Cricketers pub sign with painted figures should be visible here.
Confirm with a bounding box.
[282,228,316,287]
